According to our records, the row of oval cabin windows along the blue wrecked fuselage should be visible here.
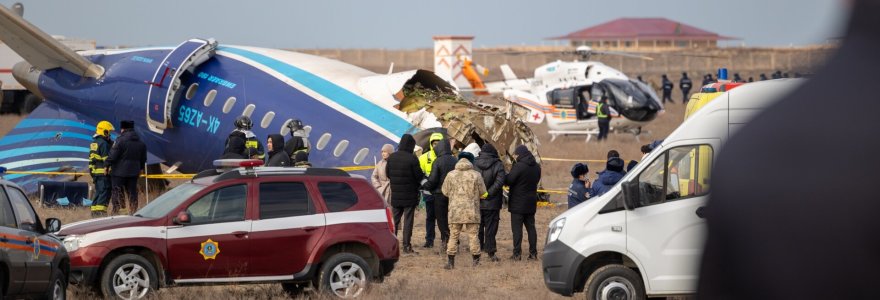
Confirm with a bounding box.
[185,83,370,165]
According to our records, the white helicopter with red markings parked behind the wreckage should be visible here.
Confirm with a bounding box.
[485,46,663,141]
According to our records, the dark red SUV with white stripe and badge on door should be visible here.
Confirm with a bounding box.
[57,160,399,299]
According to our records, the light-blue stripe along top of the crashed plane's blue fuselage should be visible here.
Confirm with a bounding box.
[218,47,412,136]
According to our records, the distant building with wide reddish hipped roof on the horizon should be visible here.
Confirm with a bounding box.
[550,18,737,50]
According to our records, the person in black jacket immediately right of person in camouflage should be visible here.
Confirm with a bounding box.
[474,143,507,261]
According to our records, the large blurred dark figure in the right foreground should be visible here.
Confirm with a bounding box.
[697,0,880,299]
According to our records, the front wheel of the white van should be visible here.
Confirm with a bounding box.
[586,265,645,300]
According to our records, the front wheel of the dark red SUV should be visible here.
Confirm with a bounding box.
[98,254,159,299]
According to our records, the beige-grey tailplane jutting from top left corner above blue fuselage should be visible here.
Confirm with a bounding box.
[0,5,104,78]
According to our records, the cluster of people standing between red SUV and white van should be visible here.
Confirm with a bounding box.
[380,132,541,269]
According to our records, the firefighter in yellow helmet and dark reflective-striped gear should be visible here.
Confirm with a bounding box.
[89,121,115,217]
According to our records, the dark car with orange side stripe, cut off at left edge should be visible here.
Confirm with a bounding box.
[0,180,70,299]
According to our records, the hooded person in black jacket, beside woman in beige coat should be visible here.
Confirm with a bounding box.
[385,134,425,253]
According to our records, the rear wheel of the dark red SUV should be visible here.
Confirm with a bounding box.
[319,253,372,298]
